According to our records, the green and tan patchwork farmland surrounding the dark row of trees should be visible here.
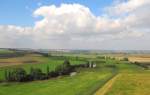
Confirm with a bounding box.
[0,51,150,95]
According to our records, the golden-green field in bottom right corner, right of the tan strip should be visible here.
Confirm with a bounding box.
[106,72,150,95]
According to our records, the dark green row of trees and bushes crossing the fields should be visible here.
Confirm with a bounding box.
[5,60,92,82]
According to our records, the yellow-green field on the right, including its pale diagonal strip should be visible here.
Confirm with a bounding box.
[94,55,150,95]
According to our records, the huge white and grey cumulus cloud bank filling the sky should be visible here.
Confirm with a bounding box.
[0,0,150,49]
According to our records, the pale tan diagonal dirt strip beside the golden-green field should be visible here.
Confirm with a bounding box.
[94,74,120,95]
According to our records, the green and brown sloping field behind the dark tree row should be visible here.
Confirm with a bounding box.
[0,55,84,80]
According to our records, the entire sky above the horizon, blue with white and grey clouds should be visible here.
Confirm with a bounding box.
[0,0,150,50]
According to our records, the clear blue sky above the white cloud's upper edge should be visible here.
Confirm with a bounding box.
[0,0,113,26]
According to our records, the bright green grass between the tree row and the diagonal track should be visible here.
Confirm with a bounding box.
[0,68,113,95]
